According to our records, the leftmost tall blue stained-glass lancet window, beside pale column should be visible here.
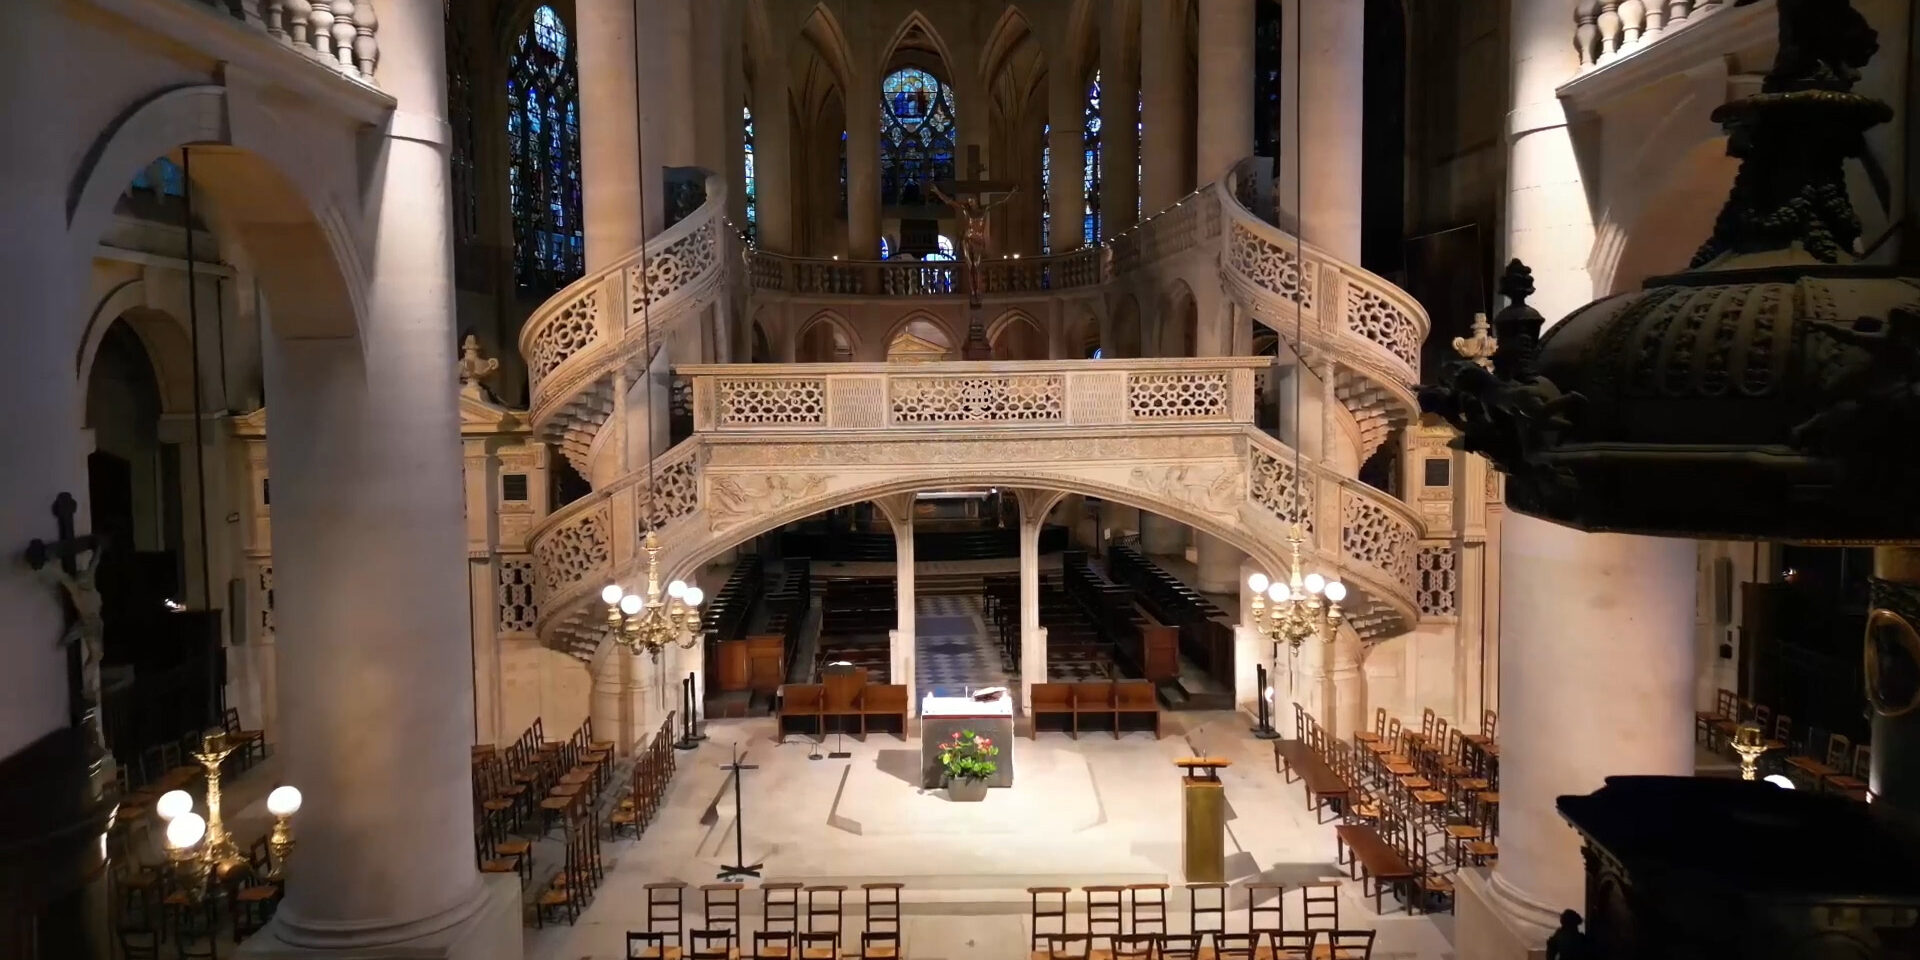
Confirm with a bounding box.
[507,6,586,292]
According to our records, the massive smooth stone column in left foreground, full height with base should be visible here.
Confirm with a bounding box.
[240,0,520,958]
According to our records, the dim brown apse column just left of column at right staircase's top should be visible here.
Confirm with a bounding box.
[1140,0,1182,217]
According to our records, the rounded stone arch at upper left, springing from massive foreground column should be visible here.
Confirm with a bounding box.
[67,86,367,338]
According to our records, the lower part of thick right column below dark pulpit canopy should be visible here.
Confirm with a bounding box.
[1457,515,1695,960]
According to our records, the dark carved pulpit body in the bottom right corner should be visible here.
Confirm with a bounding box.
[1557,776,1920,960]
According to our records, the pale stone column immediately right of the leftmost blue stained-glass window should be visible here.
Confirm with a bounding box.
[576,0,659,273]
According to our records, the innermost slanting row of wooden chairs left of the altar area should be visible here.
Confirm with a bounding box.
[534,714,678,927]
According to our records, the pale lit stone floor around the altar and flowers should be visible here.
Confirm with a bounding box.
[526,712,1453,960]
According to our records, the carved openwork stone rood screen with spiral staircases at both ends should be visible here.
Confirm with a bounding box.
[520,163,1434,659]
